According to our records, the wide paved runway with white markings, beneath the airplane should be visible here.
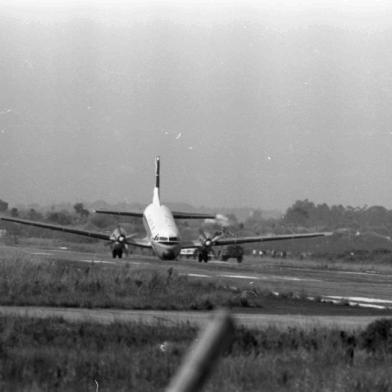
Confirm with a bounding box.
[16,243,392,307]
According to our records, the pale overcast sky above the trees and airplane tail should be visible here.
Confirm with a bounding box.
[0,0,392,210]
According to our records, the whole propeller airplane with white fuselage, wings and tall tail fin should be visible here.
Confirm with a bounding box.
[1,156,333,262]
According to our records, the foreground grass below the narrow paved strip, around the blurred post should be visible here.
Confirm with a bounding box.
[0,317,392,392]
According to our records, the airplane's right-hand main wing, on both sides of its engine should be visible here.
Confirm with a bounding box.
[181,232,333,249]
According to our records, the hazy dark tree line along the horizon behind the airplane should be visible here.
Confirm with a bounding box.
[0,199,392,235]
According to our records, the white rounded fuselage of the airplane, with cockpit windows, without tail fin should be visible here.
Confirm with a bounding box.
[143,202,181,260]
